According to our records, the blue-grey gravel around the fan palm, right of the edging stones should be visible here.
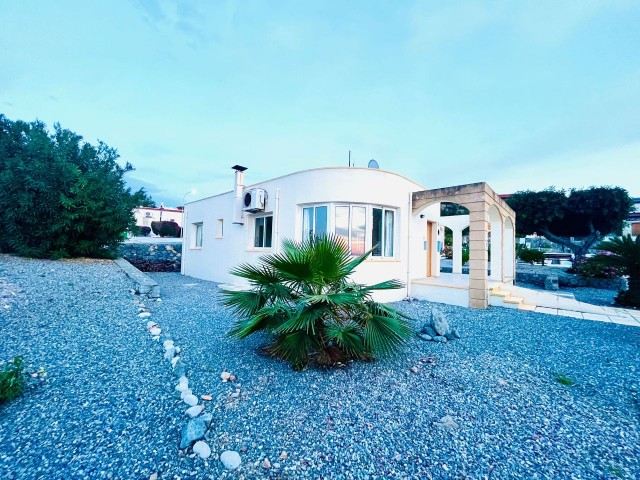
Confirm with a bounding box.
[148,273,640,479]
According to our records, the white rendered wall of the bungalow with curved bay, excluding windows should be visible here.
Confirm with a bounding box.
[182,167,424,301]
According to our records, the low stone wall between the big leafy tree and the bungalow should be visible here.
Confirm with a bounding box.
[118,242,182,272]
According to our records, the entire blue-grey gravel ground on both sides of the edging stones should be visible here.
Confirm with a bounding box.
[0,256,640,479]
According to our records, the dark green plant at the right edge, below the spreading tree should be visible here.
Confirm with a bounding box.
[592,235,640,307]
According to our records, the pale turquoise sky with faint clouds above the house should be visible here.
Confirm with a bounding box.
[0,0,640,206]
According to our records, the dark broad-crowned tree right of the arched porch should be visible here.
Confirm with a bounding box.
[506,187,633,260]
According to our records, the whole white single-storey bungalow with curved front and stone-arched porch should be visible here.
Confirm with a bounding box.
[182,165,515,308]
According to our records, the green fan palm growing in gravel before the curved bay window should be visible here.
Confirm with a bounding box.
[224,236,412,370]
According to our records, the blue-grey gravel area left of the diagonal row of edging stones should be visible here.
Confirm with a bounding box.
[0,255,183,480]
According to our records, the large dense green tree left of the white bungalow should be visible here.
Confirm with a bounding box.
[0,115,153,258]
